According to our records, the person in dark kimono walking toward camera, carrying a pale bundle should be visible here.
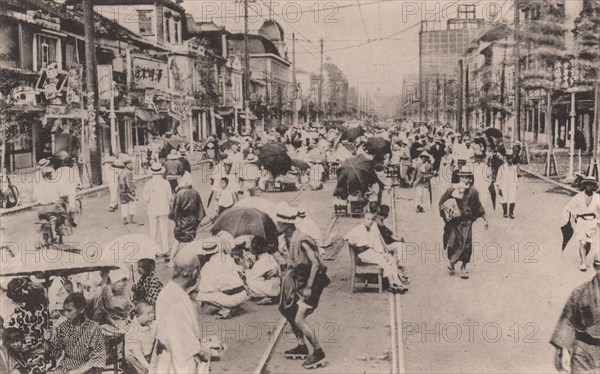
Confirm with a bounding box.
[439,166,488,279]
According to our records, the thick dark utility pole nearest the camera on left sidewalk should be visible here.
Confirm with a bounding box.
[82,0,102,185]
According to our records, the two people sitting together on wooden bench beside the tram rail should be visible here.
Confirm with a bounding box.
[345,202,408,293]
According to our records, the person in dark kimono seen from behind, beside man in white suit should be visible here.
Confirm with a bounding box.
[169,173,206,261]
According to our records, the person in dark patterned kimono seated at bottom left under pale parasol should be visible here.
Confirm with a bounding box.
[52,293,106,374]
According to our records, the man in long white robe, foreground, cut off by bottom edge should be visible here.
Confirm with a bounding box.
[150,250,210,374]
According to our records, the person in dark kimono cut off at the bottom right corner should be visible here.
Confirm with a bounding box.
[550,254,600,373]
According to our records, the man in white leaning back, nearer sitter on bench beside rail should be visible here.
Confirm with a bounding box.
[345,212,407,292]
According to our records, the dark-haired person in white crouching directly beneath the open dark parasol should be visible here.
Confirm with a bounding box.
[245,236,281,305]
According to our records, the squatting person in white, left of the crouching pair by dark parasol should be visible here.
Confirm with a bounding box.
[195,241,248,319]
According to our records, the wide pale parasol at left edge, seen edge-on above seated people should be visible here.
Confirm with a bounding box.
[0,248,119,278]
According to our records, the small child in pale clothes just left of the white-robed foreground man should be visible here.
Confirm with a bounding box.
[125,301,156,374]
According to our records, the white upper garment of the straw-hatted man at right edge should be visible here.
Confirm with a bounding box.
[563,192,600,242]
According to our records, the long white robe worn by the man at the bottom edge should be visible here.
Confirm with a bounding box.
[150,281,206,374]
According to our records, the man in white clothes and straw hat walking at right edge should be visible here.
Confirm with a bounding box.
[563,176,600,271]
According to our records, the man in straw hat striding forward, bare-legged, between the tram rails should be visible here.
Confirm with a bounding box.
[275,202,329,369]
